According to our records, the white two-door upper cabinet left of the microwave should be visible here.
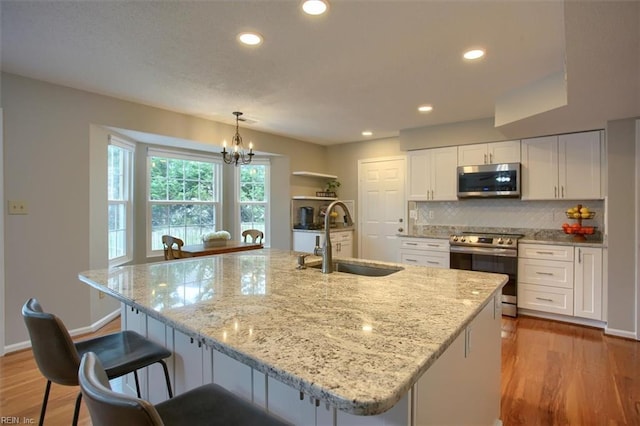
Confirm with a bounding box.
[407,146,458,201]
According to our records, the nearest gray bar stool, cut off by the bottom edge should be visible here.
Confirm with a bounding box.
[78,352,288,426]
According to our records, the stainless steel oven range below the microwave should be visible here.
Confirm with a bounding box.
[449,233,522,317]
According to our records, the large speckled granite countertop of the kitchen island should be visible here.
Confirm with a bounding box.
[79,249,507,415]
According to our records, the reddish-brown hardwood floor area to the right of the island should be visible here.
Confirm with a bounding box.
[501,316,640,426]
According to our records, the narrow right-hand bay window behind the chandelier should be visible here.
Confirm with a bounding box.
[236,159,269,243]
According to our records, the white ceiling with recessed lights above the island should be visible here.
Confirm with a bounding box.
[1,0,636,144]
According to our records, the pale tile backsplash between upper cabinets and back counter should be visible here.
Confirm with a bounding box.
[408,198,605,232]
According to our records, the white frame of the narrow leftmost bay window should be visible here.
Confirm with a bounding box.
[107,135,136,267]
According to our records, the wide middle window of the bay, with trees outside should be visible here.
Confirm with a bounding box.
[147,149,222,255]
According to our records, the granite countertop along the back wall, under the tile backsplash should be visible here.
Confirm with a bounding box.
[399,226,606,248]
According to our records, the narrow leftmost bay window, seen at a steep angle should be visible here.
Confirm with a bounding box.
[107,136,135,266]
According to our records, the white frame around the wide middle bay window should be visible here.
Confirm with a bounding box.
[145,147,224,258]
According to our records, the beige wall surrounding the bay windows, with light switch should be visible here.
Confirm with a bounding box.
[1,73,327,347]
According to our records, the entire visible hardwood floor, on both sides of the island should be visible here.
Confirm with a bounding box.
[0,316,640,426]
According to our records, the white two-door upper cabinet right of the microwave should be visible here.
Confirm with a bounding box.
[522,131,602,200]
